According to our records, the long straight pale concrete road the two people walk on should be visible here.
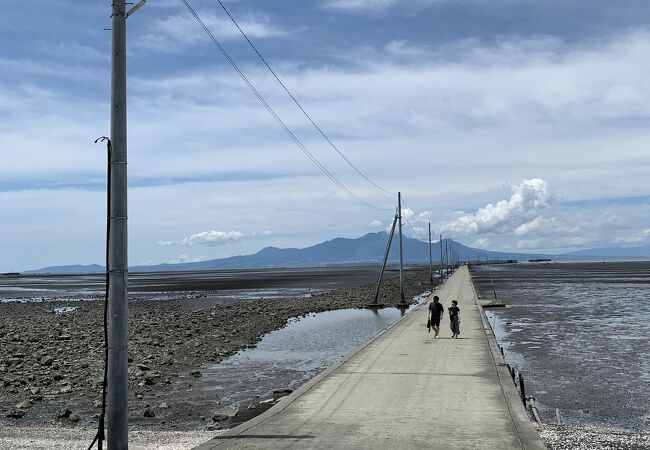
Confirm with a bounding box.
[197,267,544,450]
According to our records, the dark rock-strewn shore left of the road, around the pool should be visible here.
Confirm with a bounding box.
[0,271,436,430]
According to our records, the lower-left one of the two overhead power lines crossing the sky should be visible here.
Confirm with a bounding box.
[182,0,392,211]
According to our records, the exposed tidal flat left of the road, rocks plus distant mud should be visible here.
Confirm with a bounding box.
[0,268,430,442]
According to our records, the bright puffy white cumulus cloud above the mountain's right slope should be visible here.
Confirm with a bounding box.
[442,178,554,235]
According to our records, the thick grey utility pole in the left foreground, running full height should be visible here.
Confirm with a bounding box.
[106,0,129,450]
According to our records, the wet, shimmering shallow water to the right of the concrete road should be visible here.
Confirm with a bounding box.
[473,262,650,429]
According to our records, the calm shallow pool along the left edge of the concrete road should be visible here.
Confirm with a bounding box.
[201,293,428,405]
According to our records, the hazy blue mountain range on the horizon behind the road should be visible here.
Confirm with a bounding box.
[26,232,540,273]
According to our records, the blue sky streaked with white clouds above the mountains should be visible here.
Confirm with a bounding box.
[0,0,650,272]
